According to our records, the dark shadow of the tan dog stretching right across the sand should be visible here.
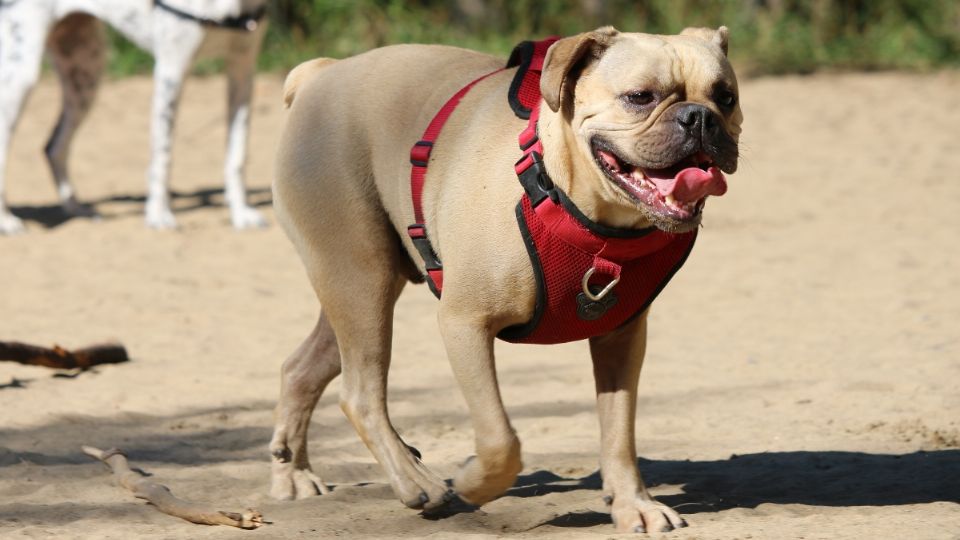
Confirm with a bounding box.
[507,449,960,527]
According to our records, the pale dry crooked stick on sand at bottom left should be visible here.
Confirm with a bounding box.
[81,446,263,529]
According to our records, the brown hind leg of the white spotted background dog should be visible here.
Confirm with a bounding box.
[46,13,106,216]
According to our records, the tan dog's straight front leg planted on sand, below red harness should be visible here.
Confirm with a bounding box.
[590,314,686,532]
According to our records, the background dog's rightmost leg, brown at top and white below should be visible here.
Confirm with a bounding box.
[223,24,267,229]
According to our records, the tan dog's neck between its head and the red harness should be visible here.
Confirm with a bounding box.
[537,101,653,229]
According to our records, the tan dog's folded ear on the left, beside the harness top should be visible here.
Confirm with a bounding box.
[540,26,619,112]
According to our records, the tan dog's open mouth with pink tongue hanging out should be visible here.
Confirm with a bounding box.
[591,141,727,223]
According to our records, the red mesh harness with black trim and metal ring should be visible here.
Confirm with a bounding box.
[408,38,696,344]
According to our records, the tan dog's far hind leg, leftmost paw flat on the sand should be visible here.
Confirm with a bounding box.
[270,313,340,500]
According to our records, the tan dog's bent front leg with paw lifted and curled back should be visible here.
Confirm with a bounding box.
[440,308,523,504]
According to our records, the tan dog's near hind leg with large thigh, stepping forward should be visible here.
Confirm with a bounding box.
[273,63,449,509]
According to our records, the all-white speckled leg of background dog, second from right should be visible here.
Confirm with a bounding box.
[146,14,204,229]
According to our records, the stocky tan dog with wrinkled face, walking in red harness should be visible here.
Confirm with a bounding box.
[270,28,742,531]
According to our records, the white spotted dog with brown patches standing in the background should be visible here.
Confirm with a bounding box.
[0,0,267,234]
